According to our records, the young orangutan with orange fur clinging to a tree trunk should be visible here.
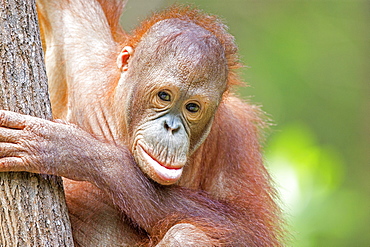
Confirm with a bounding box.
[0,0,282,246]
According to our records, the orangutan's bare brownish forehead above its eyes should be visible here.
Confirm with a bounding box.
[130,19,227,93]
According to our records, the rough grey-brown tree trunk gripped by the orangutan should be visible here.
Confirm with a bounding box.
[0,0,73,247]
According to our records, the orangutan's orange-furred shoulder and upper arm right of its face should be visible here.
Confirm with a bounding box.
[196,96,283,246]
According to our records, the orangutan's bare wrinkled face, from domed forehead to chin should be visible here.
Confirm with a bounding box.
[122,19,226,184]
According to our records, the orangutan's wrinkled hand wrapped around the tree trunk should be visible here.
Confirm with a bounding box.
[0,111,108,180]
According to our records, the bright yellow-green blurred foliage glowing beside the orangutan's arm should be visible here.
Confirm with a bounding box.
[266,123,368,246]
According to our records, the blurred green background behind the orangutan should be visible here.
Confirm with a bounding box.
[123,0,370,247]
